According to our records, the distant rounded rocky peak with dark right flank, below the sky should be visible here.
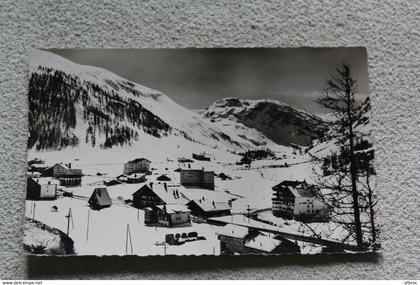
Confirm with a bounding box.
[202,98,325,146]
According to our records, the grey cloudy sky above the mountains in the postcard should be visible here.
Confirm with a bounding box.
[49,47,369,113]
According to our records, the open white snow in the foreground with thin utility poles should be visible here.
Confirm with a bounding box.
[26,197,220,256]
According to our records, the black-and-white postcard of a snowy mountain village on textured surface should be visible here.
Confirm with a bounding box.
[23,47,381,256]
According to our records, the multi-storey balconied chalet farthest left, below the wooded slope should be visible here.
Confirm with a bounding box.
[42,163,83,187]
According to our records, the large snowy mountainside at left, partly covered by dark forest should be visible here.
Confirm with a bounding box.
[28,50,268,150]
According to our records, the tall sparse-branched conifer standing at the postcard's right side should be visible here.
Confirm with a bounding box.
[317,64,363,250]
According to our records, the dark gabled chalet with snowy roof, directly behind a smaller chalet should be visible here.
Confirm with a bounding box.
[133,183,188,209]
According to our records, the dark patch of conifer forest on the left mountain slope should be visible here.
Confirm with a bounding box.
[28,67,171,150]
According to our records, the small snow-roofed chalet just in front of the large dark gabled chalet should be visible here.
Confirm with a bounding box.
[144,204,191,227]
